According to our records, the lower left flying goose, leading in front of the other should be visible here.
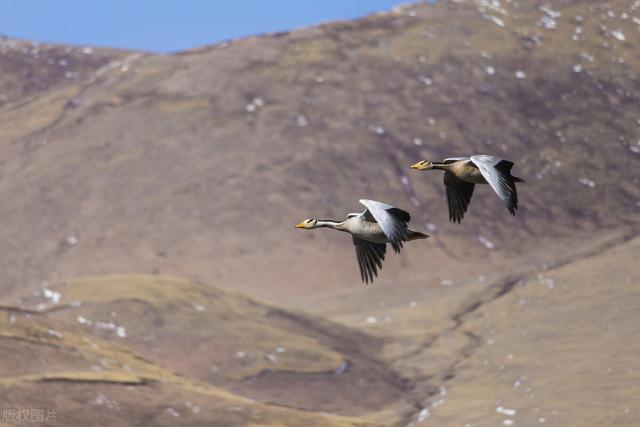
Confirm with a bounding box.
[296,199,429,283]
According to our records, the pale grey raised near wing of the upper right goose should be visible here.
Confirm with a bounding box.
[471,155,518,215]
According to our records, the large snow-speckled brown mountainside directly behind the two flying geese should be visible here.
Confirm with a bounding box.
[0,1,640,302]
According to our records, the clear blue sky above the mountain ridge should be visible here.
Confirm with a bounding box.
[0,0,416,52]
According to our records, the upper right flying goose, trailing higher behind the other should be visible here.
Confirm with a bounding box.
[411,155,524,223]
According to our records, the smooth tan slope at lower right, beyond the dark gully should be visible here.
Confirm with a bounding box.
[392,234,640,427]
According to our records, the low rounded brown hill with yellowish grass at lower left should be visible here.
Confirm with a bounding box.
[0,276,388,426]
